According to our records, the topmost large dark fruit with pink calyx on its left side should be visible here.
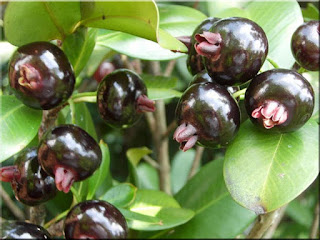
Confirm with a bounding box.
[195,17,268,86]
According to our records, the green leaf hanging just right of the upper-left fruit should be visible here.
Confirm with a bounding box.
[62,28,97,77]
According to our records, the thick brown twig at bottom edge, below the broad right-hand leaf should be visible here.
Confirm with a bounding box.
[246,209,279,239]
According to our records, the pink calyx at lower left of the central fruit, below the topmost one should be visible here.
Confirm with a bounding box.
[173,122,198,152]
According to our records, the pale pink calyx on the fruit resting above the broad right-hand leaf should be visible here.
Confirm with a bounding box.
[251,100,288,129]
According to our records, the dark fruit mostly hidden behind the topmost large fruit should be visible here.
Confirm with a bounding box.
[187,17,220,75]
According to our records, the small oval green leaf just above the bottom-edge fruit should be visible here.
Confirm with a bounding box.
[99,183,137,207]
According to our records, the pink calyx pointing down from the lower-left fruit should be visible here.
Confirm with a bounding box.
[54,166,75,193]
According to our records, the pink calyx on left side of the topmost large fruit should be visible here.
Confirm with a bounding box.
[194,32,222,61]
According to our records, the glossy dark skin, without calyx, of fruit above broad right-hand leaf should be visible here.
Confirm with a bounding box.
[245,69,314,133]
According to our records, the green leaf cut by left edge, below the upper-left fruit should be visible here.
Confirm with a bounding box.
[0,95,42,162]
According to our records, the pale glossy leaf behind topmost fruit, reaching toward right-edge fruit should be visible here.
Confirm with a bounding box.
[209,0,303,69]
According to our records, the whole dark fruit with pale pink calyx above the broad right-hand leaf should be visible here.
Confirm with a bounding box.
[245,69,314,132]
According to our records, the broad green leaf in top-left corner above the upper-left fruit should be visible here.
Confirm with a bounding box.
[4,1,81,46]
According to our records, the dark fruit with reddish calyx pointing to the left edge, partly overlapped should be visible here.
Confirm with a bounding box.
[0,148,56,206]
